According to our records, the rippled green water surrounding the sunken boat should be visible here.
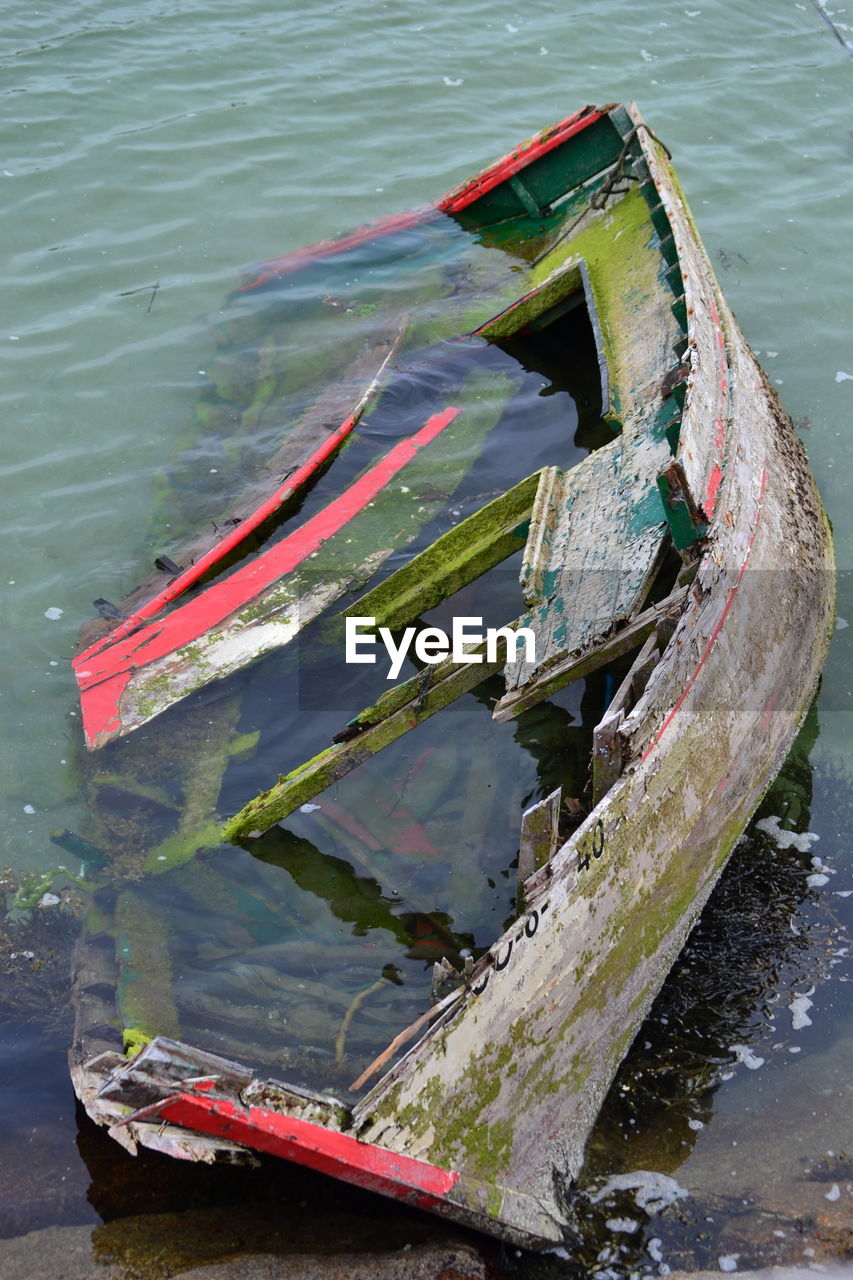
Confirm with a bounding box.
[0,0,853,1274]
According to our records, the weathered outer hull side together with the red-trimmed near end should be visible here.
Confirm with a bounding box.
[74,111,834,1248]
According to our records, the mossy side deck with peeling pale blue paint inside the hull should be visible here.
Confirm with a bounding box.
[494,183,678,696]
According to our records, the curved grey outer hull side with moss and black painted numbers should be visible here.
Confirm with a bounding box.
[345,110,833,1249]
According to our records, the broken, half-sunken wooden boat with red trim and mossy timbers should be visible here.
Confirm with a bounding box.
[72,105,834,1248]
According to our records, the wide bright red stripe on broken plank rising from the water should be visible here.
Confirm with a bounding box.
[73,407,460,746]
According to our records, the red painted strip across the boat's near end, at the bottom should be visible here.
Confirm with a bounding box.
[156,1093,459,1208]
